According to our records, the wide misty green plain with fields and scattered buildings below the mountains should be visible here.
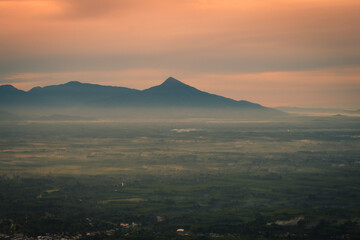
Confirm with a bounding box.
[0,118,360,239]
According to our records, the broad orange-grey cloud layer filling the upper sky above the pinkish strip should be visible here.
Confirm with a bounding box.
[0,0,360,73]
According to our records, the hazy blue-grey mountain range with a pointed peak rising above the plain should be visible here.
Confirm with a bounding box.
[0,77,282,117]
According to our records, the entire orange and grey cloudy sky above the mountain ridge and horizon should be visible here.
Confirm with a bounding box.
[0,0,360,109]
